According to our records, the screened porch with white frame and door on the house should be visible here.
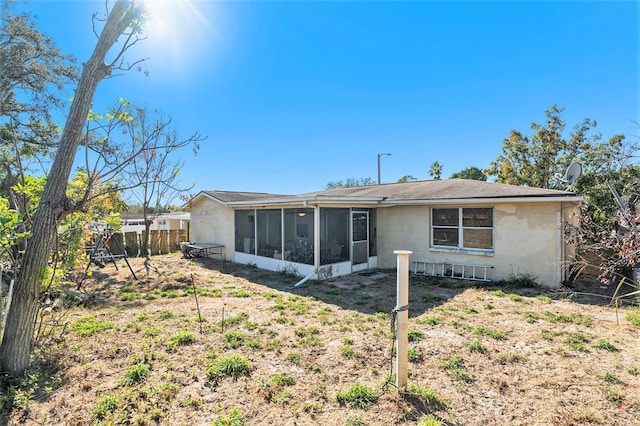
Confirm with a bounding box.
[235,207,376,276]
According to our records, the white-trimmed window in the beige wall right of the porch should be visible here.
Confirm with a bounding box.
[431,207,493,251]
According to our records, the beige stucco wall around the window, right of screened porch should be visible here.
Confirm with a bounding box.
[378,203,569,287]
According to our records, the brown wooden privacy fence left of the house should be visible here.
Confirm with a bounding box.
[108,229,189,257]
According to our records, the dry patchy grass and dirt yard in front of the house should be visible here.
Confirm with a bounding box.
[4,255,640,426]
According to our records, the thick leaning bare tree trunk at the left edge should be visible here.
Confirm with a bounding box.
[0,0,135,376]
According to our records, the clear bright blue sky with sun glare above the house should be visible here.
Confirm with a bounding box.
[26,0,640,194]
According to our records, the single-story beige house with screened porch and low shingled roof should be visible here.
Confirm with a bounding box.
[188,179,584,287]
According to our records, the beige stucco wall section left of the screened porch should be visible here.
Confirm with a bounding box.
[190,198,235,261]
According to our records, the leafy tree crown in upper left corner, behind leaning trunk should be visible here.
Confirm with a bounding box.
[0,0,77,165]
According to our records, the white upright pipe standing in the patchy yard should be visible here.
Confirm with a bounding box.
[393,250,413,390]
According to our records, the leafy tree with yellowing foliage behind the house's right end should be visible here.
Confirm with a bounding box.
[485,105,639,230]
